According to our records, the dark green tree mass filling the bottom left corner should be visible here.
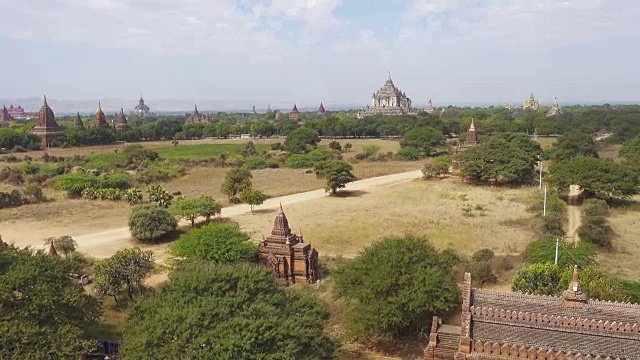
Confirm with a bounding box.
[0,245,101,360]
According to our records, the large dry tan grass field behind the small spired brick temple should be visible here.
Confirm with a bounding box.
[234,180,534,257]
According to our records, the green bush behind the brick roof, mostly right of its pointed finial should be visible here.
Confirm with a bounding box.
[560,265,631,302]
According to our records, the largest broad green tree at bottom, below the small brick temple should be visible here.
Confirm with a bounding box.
[121,263,338,360]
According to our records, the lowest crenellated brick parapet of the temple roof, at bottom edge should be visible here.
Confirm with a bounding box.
[473,341,624,360]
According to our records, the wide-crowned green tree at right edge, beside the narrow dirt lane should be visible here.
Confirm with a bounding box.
[547,156,640,198]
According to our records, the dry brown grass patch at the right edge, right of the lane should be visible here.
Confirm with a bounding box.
[598,196,640,281]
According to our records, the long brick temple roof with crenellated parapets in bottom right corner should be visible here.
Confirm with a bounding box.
[425,266,640,360]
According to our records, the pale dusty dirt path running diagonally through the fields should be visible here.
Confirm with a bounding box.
[5,170,422,261]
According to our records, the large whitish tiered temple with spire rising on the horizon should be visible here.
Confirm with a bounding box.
[358,73,416,117]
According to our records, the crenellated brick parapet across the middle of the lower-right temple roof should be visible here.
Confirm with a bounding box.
[470,306,640,335]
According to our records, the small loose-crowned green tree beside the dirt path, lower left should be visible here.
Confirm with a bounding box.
[93,248,154,304]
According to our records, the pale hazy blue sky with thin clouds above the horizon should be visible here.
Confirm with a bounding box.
[0,0,640,105]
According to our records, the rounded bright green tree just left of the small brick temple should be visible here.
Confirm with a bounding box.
[171,223,256,263]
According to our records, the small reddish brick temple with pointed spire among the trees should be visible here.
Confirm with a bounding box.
[258,205,319,283]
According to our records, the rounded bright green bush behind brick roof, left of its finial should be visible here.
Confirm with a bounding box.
[511,263,563,295]
